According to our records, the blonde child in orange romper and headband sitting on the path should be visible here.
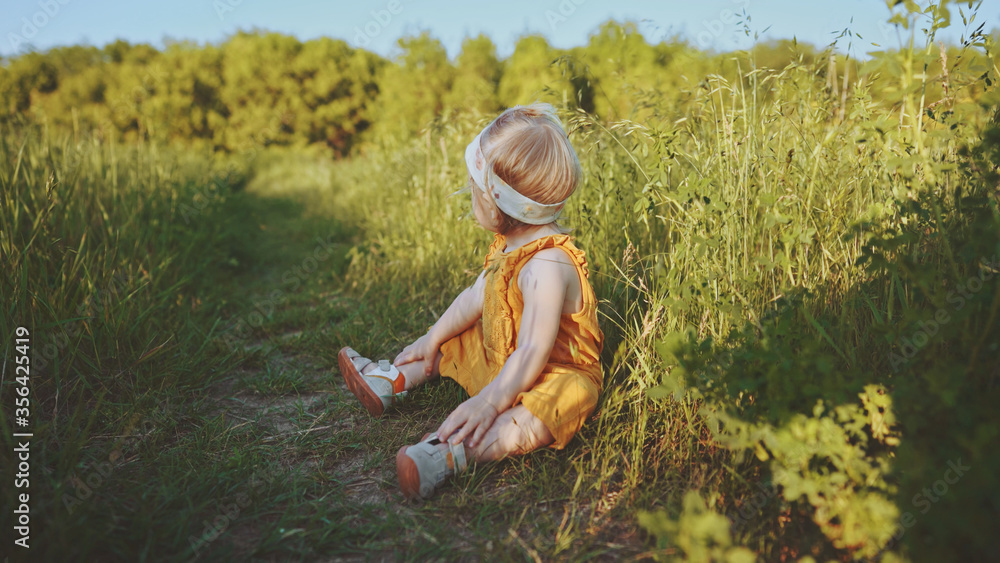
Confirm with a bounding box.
[338,104,604,498]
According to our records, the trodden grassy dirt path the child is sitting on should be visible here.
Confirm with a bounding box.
[192,188,642,560]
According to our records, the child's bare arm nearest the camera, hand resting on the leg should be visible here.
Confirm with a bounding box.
[438,248,579,447]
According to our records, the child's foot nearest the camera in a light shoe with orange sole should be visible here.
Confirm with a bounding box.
[396,434,468,500]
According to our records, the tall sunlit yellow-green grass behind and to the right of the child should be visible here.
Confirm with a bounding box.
[308,36,992,558]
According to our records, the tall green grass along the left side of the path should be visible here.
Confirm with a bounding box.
[0,124,262,557]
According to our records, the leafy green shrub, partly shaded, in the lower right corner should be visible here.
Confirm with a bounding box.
[650,87,1000,561]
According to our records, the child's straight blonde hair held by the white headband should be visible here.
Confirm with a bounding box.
[482,103,583,234]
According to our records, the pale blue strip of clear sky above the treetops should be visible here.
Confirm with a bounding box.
[0,0,1000,59]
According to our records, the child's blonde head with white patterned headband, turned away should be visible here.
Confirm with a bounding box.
[466,104,583,234]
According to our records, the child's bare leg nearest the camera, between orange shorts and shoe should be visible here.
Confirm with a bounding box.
[465,405,555,462]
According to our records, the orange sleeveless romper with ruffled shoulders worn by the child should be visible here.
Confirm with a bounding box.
[440,234,604,449]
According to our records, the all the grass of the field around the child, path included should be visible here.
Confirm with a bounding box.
[0,29,995,560]
